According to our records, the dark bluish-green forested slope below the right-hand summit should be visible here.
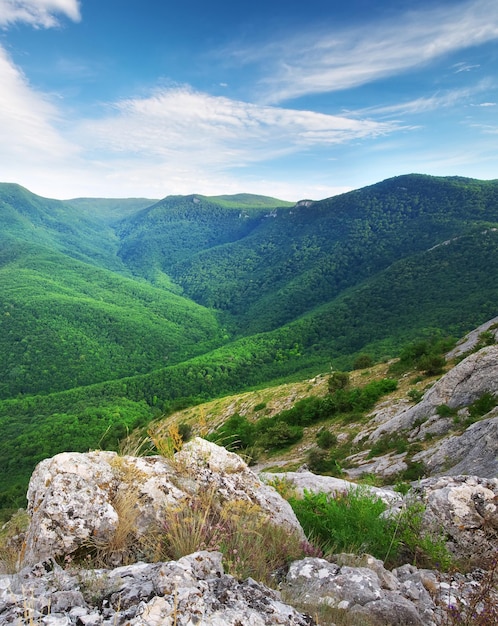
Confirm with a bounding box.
[115,175,498,335]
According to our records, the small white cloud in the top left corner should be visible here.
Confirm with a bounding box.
[0,0,81,28]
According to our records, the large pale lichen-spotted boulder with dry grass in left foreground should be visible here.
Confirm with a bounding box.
[22,438,304,565]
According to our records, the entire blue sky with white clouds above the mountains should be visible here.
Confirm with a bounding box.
[0,0,498,200]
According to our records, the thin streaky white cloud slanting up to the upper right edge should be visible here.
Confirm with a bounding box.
[238,0,498,103]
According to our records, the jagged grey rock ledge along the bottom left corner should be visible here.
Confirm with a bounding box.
[0,552,313,626]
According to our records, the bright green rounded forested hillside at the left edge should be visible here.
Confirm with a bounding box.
[0,246,222,398]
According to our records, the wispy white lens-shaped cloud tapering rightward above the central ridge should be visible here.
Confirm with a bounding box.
[77,88,396,167]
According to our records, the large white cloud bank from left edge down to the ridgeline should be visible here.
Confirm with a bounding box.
[0,42,396,199]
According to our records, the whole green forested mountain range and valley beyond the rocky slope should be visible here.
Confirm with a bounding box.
[0,175,498,506]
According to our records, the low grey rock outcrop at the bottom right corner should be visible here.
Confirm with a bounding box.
[282,554,498,626]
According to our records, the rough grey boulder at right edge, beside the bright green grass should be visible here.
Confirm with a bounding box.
[413,476,498,563]
